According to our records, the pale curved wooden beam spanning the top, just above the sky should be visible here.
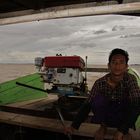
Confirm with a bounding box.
[0,2,140,25]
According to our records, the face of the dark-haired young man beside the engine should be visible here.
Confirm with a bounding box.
[108,54,128,76]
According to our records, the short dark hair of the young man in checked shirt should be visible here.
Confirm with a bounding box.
[109,48,129,64]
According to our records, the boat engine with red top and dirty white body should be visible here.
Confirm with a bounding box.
[35,55,87,95]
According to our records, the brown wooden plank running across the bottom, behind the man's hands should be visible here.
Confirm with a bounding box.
[0,111,140,140]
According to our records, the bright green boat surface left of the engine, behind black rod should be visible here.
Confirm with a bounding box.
[0,73,47,105]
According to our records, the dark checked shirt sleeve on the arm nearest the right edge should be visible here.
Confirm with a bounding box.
[118,76,140,134]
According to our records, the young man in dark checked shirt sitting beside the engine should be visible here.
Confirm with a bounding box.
[66,48,140,140]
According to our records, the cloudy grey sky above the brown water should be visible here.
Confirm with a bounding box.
[0,15,140,64]
